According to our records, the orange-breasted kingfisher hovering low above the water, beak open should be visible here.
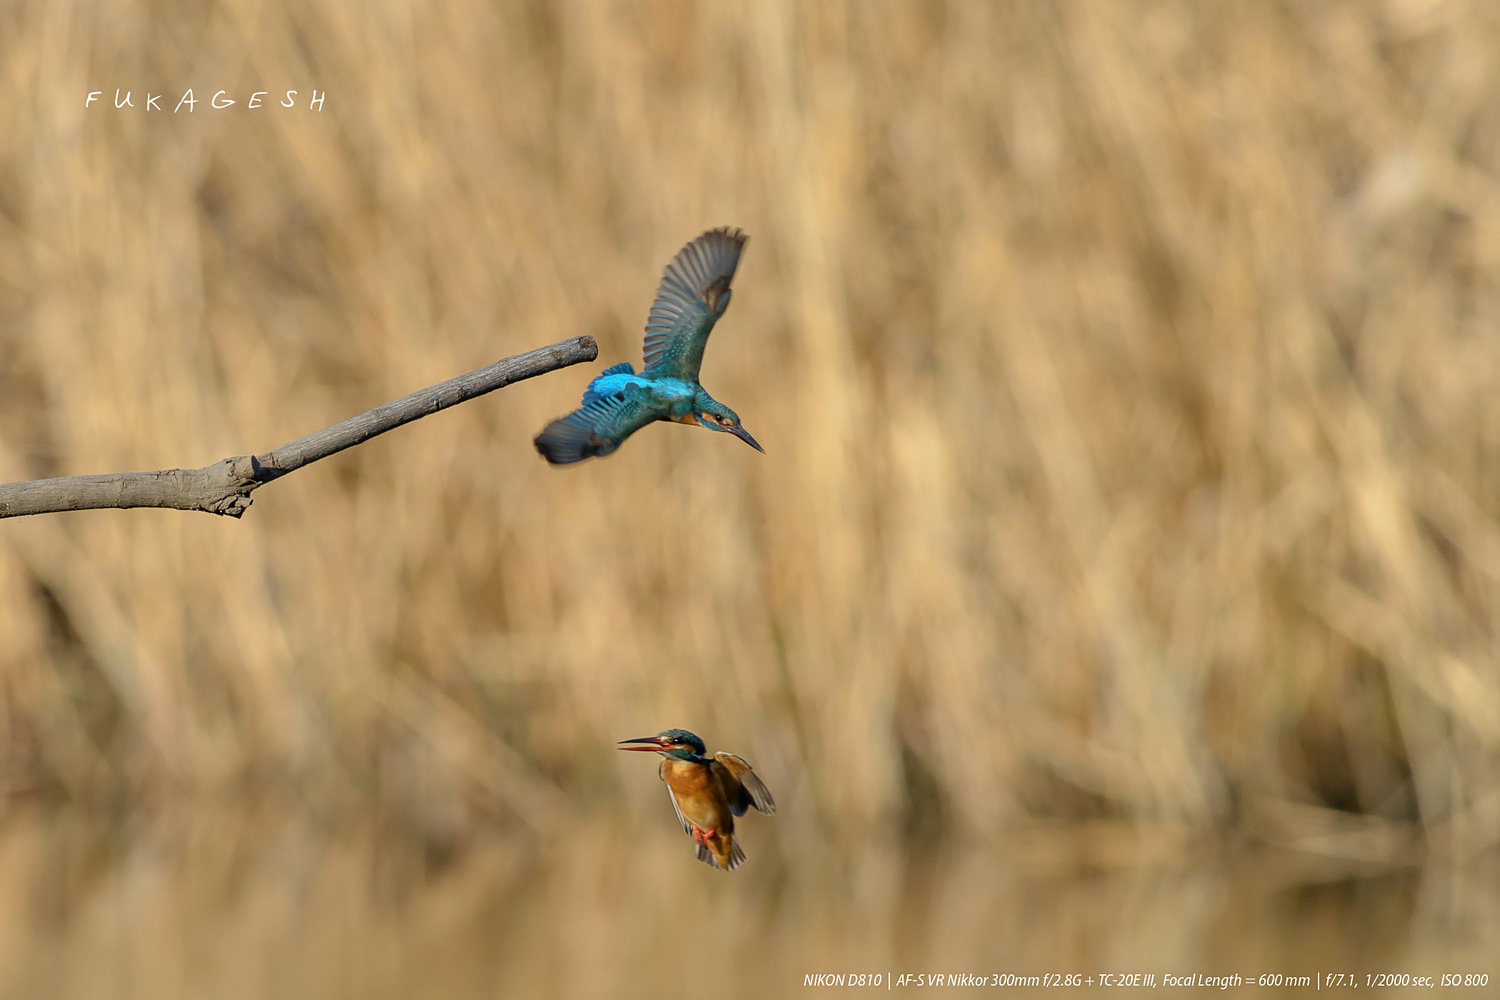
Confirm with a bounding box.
[620,729,776,871]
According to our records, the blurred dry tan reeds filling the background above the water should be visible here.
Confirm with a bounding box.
[0,0,1500,995]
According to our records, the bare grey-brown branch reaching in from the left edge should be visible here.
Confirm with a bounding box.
[0,337,599,517]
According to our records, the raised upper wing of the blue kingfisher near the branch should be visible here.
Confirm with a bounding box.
[642,226,749,382]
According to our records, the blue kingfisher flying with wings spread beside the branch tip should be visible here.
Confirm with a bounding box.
[536,226,765,465]
